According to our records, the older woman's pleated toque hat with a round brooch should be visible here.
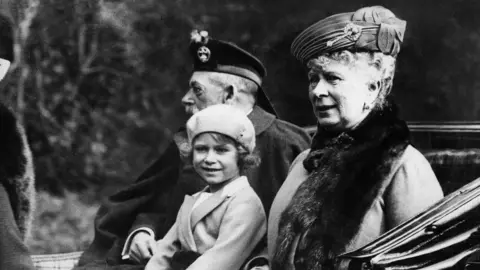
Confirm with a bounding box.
[291,6,407,63]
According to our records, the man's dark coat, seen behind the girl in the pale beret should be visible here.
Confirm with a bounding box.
[76,107,310,269]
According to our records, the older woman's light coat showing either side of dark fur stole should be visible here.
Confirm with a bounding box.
[267,146,443,269]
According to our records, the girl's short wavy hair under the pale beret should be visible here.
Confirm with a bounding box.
[179,132,261,175]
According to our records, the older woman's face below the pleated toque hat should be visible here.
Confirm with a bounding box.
[308,56,379,131]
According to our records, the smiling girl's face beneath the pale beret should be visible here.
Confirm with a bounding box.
[193,133,240,189]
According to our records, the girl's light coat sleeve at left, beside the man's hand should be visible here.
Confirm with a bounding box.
[145,211,181,270]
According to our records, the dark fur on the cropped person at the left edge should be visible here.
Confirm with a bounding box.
[0,104,35,240]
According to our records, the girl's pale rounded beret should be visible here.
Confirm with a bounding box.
[187,104,255,153]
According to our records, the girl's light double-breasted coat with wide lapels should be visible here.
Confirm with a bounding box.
[145,177,267,270]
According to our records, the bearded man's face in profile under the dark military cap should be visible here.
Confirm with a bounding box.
[182,71,226,115]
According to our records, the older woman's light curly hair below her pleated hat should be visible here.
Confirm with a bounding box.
[307,50,396,109]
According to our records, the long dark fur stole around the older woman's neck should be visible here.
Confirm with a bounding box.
[272,106,410,270]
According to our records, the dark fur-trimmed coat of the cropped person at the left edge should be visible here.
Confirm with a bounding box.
[0,104,35,270]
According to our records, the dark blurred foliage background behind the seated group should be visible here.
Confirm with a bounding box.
[0,0,480,252]
